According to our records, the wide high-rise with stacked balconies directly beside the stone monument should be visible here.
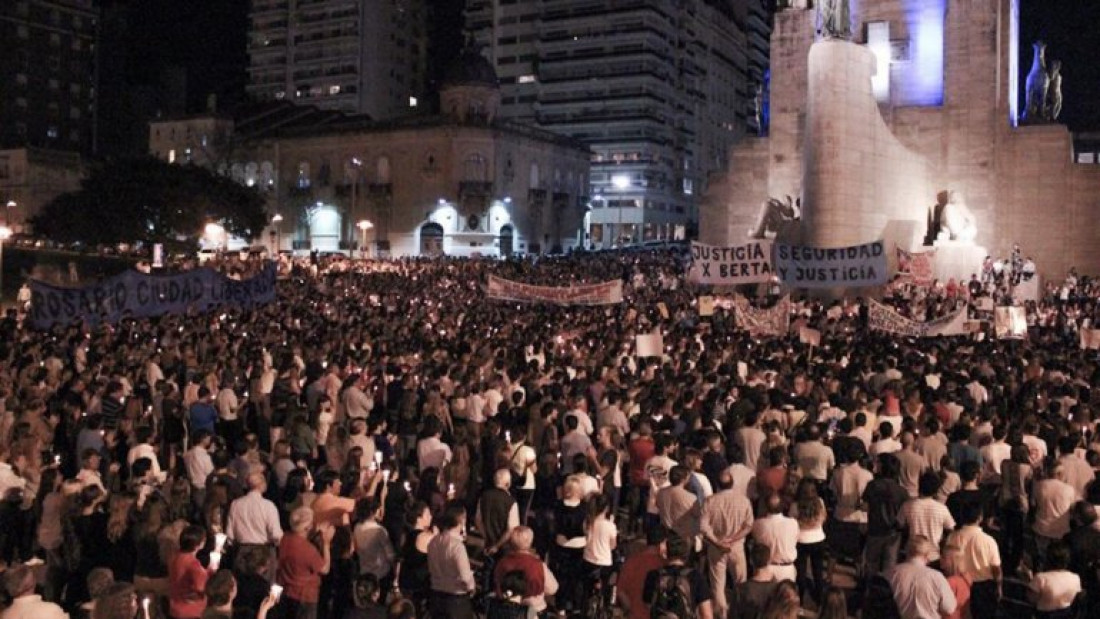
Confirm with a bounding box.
[466,0,771,247]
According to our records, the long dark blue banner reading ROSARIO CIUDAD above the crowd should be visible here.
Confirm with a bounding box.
[30,263,275,329]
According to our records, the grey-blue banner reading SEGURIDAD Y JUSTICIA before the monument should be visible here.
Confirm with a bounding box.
[774,241,887,288]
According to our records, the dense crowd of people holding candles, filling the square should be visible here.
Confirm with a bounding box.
[0,250,1100,619]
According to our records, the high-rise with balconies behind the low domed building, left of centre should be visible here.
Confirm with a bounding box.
[248,0,428,120]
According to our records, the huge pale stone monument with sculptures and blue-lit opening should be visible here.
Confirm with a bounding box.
[700,0,1100,278]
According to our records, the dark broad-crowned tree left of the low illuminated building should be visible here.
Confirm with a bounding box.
[31,157,267,245]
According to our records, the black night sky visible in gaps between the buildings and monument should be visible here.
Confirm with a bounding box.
[116,0,1100,131]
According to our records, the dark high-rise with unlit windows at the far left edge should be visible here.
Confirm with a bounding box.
[0,0,99,152]
